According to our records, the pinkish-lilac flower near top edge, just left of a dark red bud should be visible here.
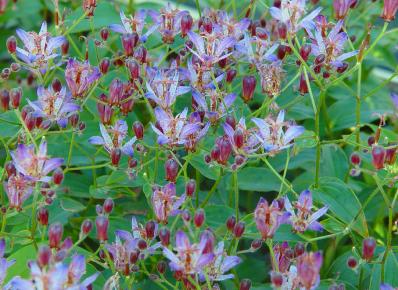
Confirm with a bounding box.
[148,3,189,43]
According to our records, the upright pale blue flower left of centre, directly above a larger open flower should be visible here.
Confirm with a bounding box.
[145,69,191,110]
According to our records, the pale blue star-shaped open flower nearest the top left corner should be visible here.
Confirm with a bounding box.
[16,22,65,71]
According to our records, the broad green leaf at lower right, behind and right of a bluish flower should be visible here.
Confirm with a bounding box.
[313,177,368,237]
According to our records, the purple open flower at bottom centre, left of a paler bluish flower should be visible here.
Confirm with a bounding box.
[163,230,215,275]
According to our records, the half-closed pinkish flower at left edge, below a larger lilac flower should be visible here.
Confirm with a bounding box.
[4,174,33,211]
